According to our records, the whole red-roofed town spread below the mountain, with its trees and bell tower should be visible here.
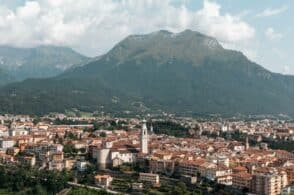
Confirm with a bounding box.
[0,114,294,195]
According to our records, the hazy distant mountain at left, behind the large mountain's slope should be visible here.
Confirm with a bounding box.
[0,46,89,83]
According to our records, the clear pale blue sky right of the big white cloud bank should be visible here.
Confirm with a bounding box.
[179,0,294,74]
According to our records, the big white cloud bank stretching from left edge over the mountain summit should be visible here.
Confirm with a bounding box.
[0,0,255,55]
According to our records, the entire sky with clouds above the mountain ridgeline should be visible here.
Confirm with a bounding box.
[0,0,294,75]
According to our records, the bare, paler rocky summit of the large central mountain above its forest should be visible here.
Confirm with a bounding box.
[107,30,224,64]
